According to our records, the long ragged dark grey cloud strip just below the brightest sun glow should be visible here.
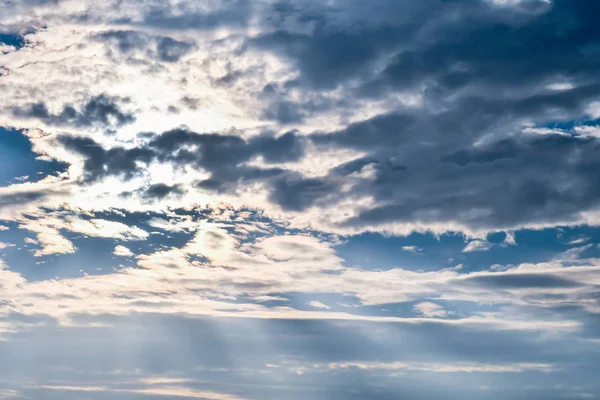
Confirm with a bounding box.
[57,129,304,188]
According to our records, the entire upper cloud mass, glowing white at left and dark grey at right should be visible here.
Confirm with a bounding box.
[2,0,600,241]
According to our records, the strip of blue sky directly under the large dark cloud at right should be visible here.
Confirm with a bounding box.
[336,226,600,273]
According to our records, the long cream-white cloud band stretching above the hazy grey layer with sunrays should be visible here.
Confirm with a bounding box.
[0,223,600,332]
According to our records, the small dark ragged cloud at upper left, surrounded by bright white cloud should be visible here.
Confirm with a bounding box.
[13,94,135,127]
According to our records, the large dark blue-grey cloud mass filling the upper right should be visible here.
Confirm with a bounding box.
[253,0,600,228]
